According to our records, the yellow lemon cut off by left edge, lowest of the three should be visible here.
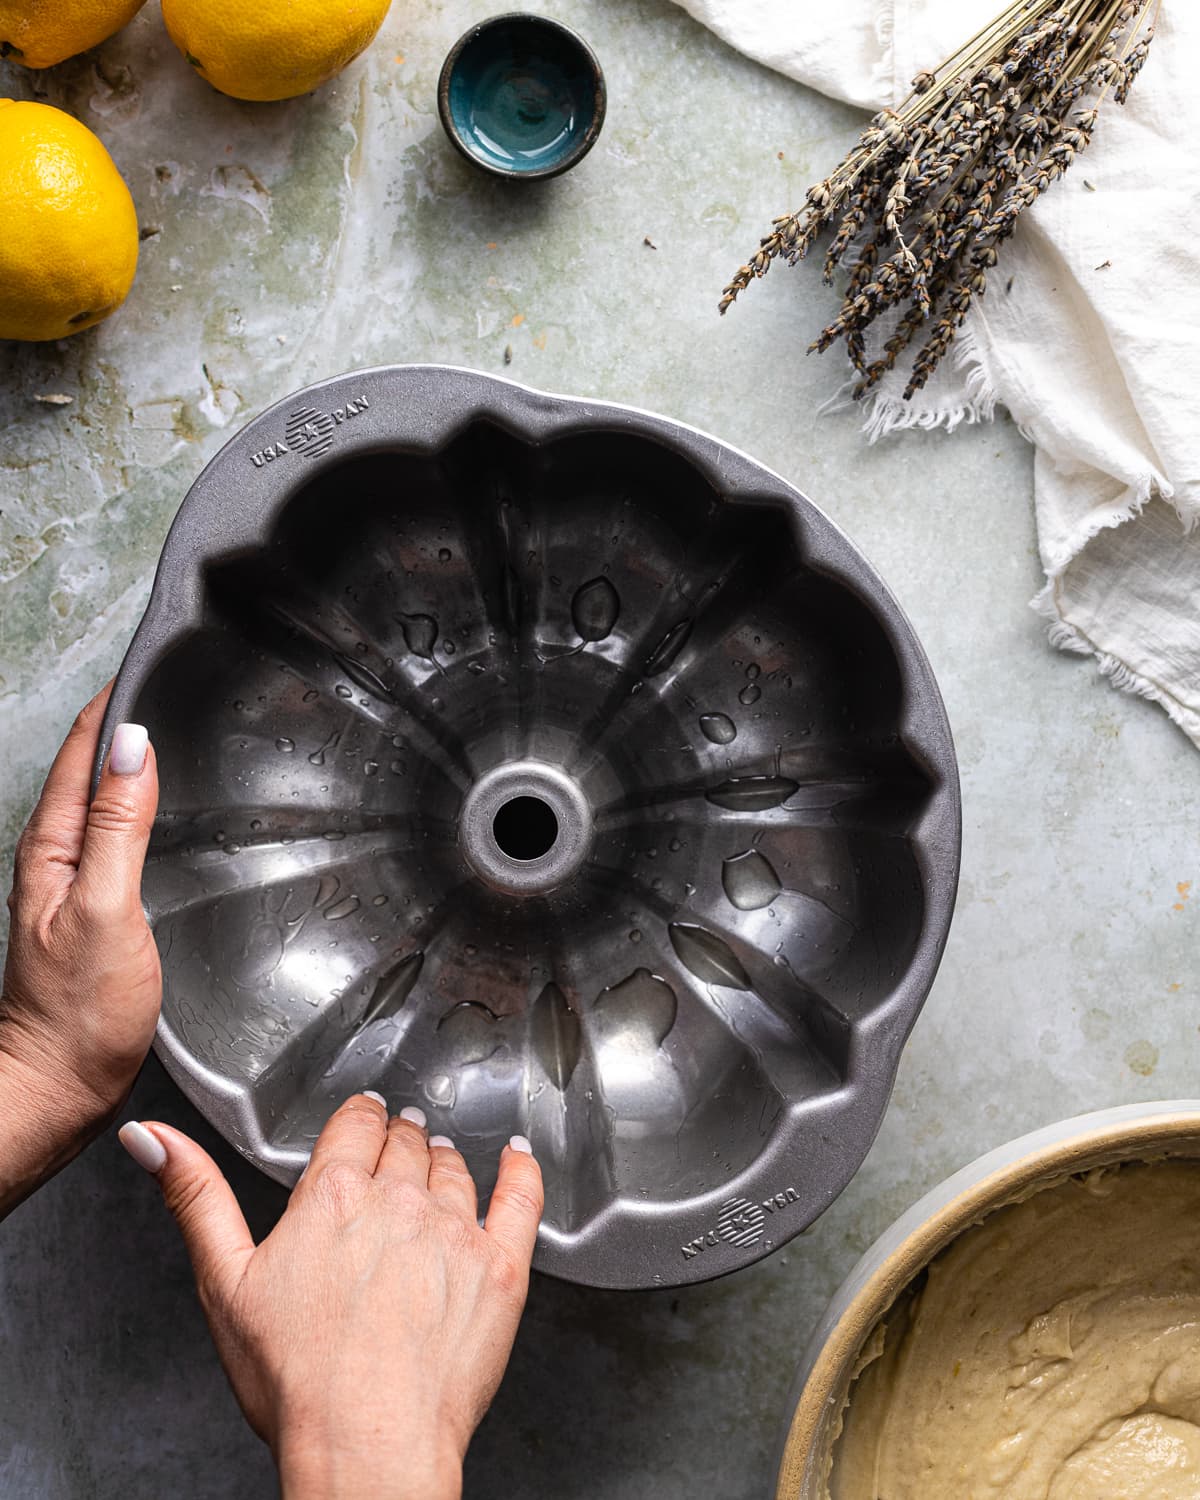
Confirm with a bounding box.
[0,99,138,341]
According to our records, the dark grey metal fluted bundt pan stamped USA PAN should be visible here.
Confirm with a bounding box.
[102,366,960,1287]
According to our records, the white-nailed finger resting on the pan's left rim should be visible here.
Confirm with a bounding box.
[77,725,159,912]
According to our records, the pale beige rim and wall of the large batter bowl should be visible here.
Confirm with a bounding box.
[774,1100,1200,1500]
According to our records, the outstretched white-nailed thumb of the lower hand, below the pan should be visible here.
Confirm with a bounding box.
[117,1121,255,1304]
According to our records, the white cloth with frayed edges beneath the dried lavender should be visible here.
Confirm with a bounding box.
[677,0,1200,746]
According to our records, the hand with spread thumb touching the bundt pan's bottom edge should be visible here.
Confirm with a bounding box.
[122,1094,542,1500]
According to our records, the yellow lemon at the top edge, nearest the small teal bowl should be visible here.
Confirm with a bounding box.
[162,0,392,101]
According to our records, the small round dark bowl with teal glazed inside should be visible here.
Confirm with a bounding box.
[438,12,606,182]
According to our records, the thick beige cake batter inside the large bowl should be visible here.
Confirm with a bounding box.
[830,1161,1200,1500]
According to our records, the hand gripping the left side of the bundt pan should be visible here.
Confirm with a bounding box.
[0,689,162,1217]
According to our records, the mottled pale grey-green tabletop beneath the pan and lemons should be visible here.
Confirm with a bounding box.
[0,0,1200,1500]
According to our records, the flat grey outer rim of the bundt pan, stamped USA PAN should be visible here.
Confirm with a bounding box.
[96,365,962,1289]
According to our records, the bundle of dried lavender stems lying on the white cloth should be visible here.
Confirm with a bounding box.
[720,0,1161,401]
